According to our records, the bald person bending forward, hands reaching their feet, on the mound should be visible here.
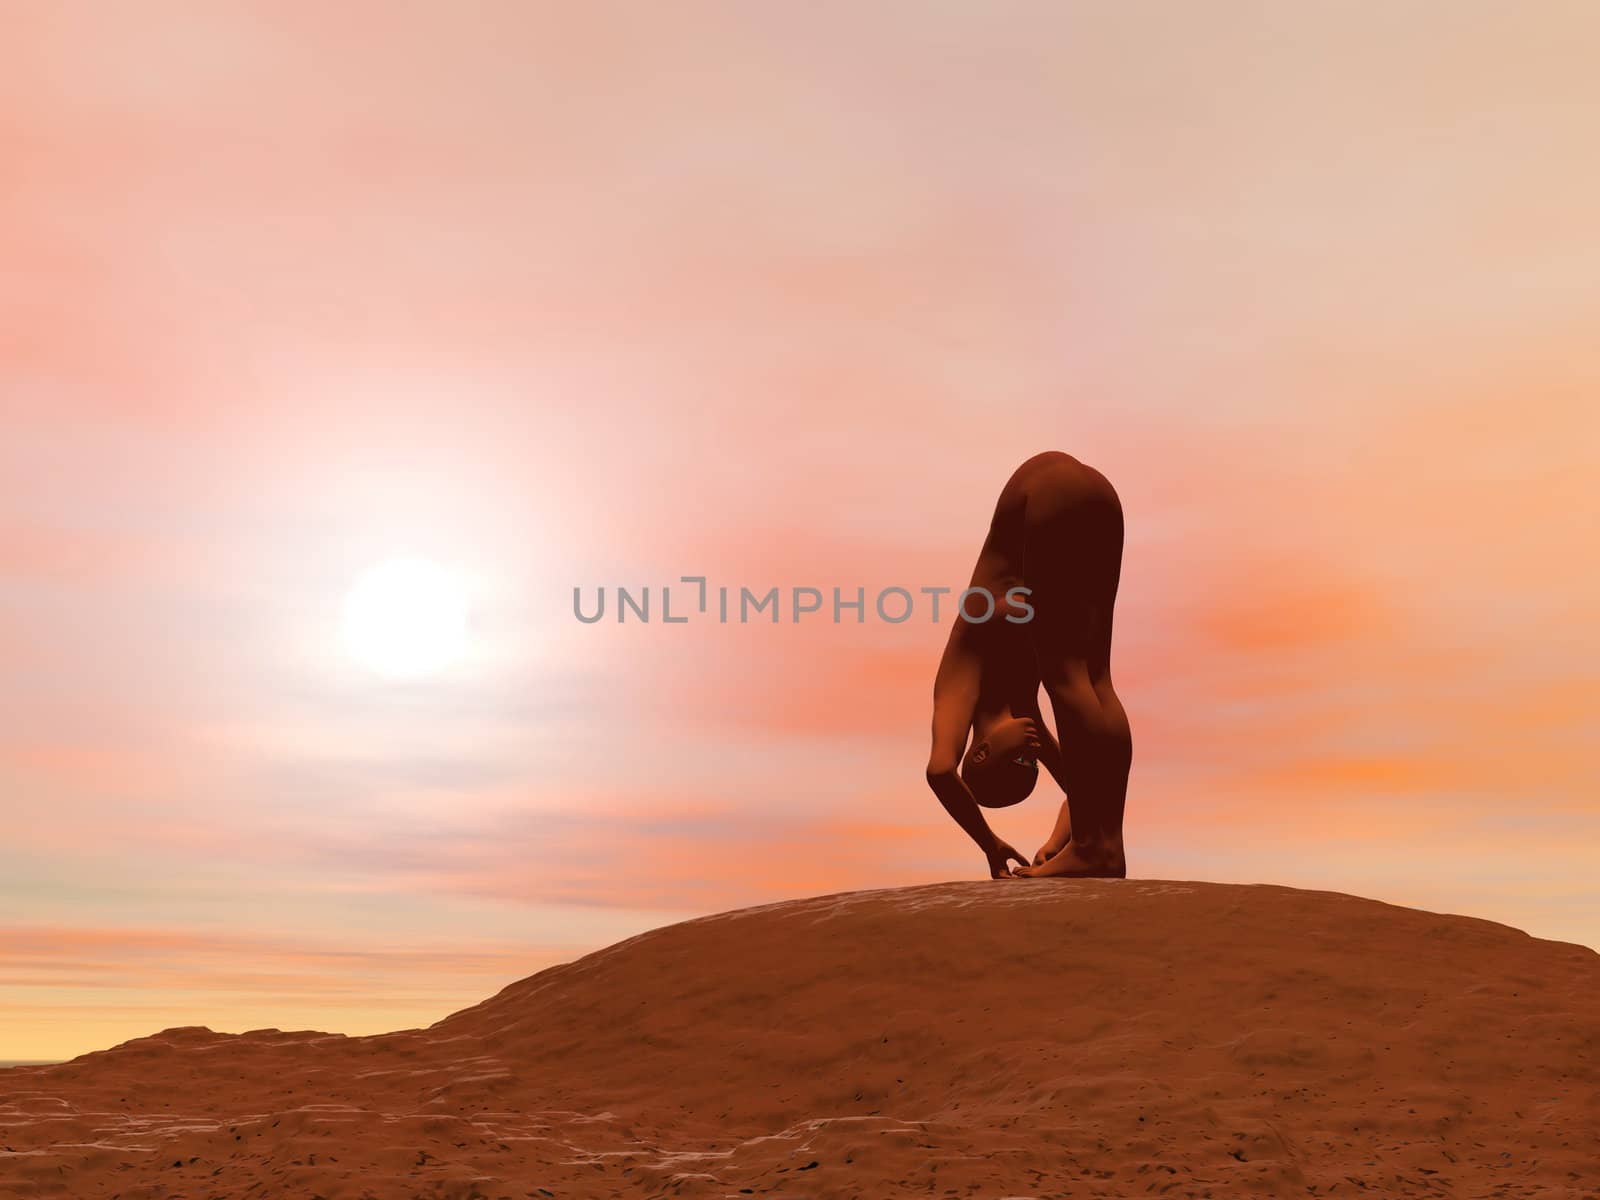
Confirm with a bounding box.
[926,451,1133,878]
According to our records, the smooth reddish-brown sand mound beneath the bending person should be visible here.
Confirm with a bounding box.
[0,880,1600,1200]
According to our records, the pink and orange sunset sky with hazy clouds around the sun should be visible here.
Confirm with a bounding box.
[0,0,1600,1059]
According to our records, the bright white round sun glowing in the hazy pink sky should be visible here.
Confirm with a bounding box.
[344,558,467,678]
